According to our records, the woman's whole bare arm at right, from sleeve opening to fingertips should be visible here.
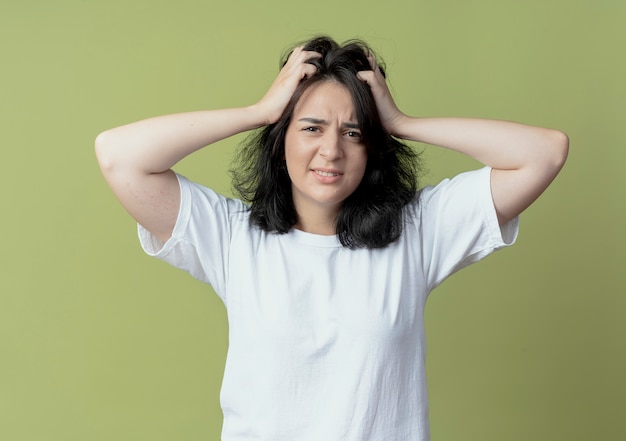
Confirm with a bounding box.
[359,58,569,224]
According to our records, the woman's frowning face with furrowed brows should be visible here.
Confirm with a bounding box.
[285,81,367,227]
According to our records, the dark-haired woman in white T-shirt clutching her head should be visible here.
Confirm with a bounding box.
[96,37,568,441]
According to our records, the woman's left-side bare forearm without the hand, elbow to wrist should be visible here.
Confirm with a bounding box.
[96,106,264,174]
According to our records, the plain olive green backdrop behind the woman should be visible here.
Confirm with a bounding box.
[0,0,626,441]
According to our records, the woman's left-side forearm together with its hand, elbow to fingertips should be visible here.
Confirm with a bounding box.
[96,48,320,175]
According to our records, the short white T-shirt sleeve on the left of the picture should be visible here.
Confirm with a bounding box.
[138,174,247,298]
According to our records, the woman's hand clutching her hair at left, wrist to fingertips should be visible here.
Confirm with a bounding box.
[254,46,321,125]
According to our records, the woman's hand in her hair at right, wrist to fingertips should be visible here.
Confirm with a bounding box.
[357,54,406,136]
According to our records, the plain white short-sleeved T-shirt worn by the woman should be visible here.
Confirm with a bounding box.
[139,167,518,441]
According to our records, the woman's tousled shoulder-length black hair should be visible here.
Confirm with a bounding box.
[231,37,419,248]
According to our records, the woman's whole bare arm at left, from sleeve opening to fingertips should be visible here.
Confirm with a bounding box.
[96,48,319,241]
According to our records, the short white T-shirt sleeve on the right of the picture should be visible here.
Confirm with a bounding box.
[416,167,519,291]
